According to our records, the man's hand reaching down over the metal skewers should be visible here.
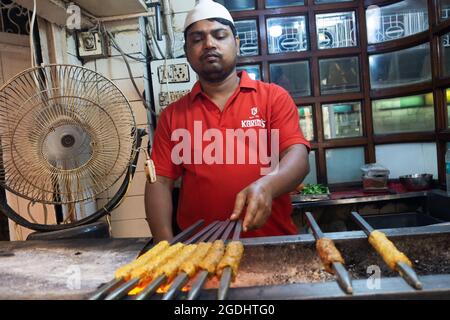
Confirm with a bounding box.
[230,181,273,231]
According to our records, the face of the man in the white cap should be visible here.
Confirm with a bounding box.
[185,20,239,82]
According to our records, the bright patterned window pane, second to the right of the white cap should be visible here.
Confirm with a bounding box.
[267,16,308,54]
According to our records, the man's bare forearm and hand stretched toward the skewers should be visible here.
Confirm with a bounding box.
[231,144,309,231]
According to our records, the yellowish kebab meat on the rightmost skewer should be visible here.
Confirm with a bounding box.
[369,230,412,271]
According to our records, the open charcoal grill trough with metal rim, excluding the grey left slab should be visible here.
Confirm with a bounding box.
[89,213,450,300]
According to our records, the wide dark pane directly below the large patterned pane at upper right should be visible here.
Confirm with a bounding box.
[369,43,431,89]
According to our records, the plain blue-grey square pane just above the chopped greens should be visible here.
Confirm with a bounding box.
[325,147,365,183]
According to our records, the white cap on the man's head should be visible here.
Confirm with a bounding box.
[184,0,234,30]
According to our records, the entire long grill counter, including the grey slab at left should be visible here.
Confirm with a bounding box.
[0,206,450,300]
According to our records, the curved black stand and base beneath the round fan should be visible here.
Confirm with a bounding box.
[0,129,147,240]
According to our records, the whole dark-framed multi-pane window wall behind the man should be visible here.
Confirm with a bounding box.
[229,0,450,184]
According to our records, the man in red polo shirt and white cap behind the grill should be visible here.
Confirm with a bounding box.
[145,0,310,241]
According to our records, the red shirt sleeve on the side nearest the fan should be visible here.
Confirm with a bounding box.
[151,109,182,180]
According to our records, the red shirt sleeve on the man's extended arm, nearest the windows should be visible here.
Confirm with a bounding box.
[271,85,311,153]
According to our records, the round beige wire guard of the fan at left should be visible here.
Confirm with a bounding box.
[0,65,136,204]
